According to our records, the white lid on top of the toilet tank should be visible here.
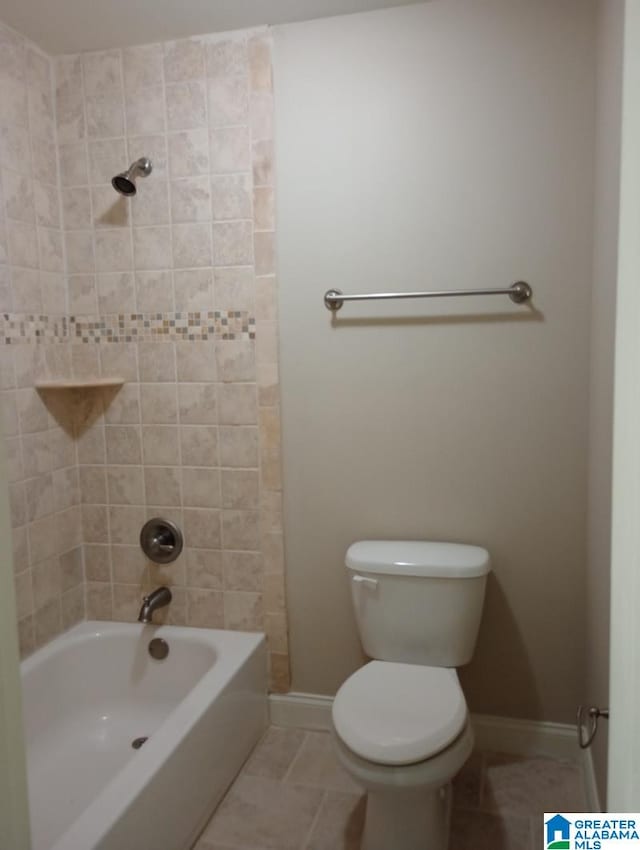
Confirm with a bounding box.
[345,540,491,578]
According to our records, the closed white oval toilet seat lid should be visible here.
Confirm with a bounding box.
[333,661,467,765]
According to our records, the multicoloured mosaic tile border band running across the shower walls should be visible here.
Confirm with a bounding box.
[1,310,256,345]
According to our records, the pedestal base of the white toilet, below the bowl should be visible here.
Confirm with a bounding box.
[361,783,452,850]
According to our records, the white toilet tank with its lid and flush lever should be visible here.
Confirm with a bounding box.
[345,540,490,667]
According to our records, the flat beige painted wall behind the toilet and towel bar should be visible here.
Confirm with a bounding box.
[275,0,595,722]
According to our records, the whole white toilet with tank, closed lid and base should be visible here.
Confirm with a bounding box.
[332,540,490,850]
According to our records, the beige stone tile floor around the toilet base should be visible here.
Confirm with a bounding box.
[194,726,586,850]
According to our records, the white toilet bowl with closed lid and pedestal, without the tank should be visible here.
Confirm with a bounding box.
[332,661,473,850]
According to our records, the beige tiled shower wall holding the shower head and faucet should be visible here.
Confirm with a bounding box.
[0,23,289,690]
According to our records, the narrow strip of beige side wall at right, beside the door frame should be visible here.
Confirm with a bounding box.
[584,0,624,804]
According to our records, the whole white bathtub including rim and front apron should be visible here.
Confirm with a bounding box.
[22,622,268,850]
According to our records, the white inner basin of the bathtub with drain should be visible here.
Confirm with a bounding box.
[24,628,216,850]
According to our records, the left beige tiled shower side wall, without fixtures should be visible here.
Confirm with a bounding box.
[0,25,84,653]
